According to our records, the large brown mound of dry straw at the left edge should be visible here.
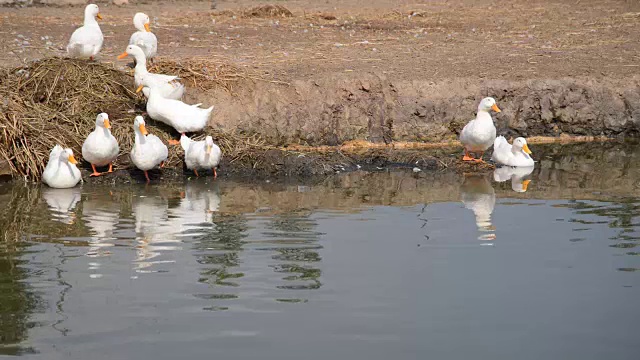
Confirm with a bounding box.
[0,58,139,179]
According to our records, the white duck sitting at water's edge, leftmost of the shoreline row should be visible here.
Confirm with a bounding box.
[42,145,82,189]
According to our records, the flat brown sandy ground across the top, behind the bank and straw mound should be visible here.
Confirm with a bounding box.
[0,0,640,81]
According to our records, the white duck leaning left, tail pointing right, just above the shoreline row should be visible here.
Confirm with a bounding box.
[136,75,213,141]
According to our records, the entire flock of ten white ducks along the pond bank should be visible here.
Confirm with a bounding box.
[43,4,534,190]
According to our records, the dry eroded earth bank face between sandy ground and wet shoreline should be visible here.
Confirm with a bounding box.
[202,73,640,145]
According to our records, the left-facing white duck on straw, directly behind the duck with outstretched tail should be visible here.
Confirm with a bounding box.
[118,45,184,100]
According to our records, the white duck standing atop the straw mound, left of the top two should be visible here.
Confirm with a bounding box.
[67,4,104,60]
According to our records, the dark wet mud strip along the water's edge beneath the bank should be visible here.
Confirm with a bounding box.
[0,139,639,185]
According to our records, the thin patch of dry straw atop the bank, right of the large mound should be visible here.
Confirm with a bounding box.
[149,58,250,93]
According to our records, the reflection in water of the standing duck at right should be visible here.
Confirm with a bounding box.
[460,174,496,241]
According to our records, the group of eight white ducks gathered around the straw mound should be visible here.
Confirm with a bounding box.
[42,4,222,188]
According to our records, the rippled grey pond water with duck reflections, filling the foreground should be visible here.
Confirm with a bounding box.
[0,144,640,360]
